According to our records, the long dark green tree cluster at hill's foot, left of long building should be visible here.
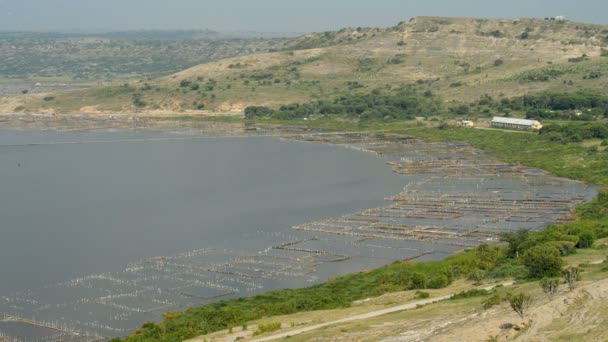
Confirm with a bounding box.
[245,90,441,120]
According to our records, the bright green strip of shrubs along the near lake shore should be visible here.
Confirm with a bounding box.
[115,190,608,342]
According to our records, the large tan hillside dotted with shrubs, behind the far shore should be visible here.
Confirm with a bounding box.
[0,17,608,113]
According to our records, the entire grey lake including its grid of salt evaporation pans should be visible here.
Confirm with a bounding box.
[0,130,595,341]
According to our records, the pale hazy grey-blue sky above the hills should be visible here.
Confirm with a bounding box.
[0,0,608,32]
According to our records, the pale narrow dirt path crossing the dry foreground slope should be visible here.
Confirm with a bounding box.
[251,281,514,342]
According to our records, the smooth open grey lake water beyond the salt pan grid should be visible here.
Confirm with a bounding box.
[0,130,404,340]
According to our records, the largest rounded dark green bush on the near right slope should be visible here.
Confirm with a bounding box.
[523,245,563,278]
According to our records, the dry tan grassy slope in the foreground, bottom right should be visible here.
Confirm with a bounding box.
[191,248,608,342]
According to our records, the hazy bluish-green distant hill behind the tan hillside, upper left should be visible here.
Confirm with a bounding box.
[0,30,290,83]
